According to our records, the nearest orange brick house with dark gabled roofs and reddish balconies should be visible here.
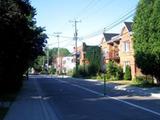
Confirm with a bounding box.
[100,22,141,78]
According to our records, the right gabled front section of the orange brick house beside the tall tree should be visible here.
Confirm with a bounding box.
[119,22,141,78]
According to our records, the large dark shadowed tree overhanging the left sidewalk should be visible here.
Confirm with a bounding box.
[0,0,47,92]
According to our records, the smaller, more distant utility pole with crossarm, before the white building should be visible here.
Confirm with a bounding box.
[54,32,62,74]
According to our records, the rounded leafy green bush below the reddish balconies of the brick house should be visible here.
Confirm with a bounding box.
[106,61,123,80]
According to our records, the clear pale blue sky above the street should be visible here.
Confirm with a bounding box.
[30,0,139,52]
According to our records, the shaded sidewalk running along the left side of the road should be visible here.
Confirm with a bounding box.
[4,79,58,120]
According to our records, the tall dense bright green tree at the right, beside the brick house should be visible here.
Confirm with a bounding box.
[133,0,160,83]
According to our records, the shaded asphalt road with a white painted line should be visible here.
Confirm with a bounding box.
[31,76,160,120]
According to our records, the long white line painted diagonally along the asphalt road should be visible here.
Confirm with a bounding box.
[60,80,160,116]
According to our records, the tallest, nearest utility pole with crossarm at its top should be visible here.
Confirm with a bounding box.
[70,20,81,75]
